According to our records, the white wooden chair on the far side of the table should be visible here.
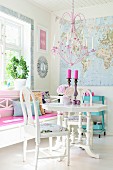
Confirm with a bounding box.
[64,89,93,146]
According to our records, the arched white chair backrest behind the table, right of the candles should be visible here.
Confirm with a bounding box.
[81,89,92,105]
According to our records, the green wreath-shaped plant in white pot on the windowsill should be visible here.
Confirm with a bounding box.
[6,56,29,90]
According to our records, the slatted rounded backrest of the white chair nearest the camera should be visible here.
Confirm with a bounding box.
[20,87,40,143]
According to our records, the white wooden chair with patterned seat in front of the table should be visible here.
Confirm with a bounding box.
[20,87,70,170]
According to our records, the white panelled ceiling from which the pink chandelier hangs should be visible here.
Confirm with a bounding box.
[29,0,113,12]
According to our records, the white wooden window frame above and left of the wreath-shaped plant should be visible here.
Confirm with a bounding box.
[0,17,24,84]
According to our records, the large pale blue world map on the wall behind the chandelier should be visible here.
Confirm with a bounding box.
[60,16,113,86]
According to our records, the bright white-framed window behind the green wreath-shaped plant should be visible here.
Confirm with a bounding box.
[0,13,31,85]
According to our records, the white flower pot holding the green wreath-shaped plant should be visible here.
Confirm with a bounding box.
[14,79,26,90]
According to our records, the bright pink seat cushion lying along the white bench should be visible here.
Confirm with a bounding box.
[0,113,57,127]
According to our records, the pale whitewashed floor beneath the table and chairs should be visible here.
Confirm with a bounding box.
[0,136,113,170]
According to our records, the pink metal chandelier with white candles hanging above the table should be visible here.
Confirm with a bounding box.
[52,0,95,66]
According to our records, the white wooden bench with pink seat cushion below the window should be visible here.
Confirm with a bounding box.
[0,90,57,148]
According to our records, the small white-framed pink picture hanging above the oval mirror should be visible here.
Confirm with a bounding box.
[38,26,48,52]
